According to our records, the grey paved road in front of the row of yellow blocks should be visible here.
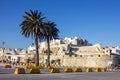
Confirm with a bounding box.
[0,72,120,80]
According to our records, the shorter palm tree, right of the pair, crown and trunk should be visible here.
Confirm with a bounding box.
[44,21,59,66]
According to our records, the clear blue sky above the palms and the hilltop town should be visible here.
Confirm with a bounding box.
[0,0,120,48]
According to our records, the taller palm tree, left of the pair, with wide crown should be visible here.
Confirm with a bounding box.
[20,10,45,66]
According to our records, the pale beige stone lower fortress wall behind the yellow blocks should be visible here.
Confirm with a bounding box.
[62,55,112,67]
